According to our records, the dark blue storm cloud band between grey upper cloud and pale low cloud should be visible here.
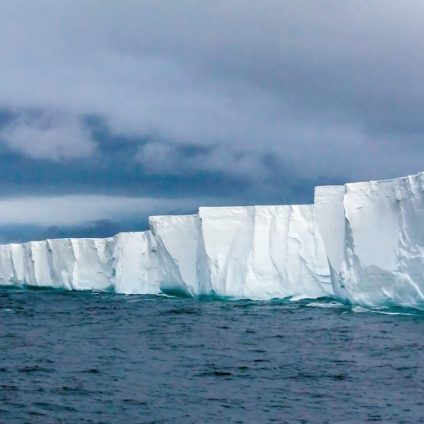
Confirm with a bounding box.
[0,113,311,205]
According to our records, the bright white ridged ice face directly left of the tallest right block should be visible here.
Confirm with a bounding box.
[250,205,332,298]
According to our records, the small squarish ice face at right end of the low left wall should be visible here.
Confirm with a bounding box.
[112,231,160,294]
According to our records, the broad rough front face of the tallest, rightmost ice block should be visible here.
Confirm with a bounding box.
[341,174,424,306]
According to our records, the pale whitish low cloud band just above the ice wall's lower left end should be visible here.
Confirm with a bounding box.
[0,195,209,243]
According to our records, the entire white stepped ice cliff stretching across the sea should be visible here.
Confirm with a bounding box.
[0,173,424,307]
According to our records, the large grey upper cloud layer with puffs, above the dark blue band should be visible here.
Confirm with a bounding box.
[0,0,424,197]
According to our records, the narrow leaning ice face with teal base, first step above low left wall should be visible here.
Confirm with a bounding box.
[149,215,207,296]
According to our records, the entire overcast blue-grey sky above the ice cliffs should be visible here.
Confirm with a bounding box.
[0,0,424,241]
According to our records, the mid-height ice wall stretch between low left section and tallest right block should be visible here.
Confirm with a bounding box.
[149,206,333,299]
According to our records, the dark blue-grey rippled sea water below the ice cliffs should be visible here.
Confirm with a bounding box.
[0,289,424,424]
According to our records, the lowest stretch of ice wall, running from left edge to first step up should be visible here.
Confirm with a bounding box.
[0,232,159,293]
